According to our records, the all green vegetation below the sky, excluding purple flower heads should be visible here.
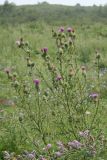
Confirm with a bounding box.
[0,3,107,160]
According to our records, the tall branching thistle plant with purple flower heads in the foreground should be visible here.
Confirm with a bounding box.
[3,27,105,160]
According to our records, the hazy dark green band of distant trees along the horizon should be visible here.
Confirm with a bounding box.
[0,2,107,25]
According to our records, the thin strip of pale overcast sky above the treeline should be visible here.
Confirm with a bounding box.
[0,0,107,6]
